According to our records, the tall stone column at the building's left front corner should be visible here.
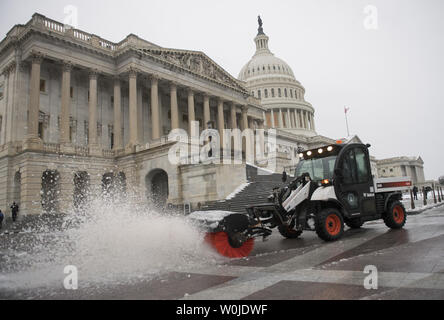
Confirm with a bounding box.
[25,54,43,149]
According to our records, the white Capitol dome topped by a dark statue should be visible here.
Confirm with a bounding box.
[238,17,316,136]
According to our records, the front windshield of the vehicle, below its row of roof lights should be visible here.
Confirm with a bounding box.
[296,156,337,181]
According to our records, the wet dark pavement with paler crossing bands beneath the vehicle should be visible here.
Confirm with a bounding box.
[0,206,444,300]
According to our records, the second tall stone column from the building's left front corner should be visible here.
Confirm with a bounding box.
[60,62,72,144]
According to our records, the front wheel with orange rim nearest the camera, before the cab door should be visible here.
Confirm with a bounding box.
[315,208,344,241]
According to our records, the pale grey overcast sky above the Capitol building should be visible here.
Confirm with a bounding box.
[0,0,444,179]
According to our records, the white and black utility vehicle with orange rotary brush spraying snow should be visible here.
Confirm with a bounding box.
[196,141,412,258]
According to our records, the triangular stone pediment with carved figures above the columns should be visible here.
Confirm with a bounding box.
[139,48,247,93]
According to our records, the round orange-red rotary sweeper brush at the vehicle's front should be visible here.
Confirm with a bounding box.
[205,232,254,258]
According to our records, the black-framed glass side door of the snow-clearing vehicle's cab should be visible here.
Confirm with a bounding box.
[333,143,376,218]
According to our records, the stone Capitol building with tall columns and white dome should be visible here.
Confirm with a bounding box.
[0,14,424,216]
